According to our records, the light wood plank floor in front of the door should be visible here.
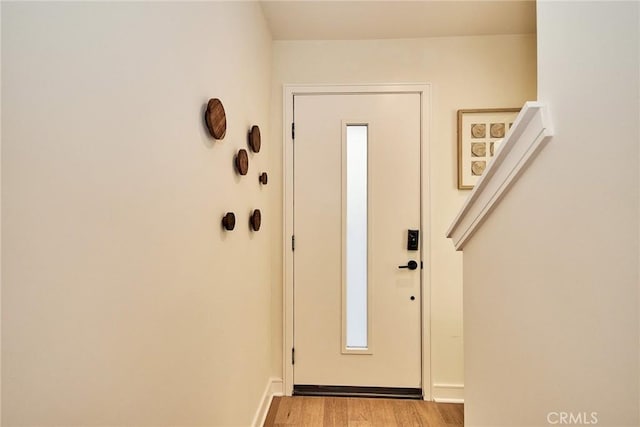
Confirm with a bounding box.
[264,397,464,427]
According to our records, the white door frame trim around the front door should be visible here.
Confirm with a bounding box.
[282,83,432,400]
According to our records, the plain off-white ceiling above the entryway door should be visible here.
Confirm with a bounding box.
[260,0,536,40]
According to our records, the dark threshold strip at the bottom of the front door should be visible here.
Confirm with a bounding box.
[293,384,423,400]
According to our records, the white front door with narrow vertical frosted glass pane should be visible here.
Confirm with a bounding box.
[293,93,423,394]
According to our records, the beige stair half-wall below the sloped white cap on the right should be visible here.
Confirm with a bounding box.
[464,1,640,427]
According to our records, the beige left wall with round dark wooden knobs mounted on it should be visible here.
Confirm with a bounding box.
[2,2,280,426]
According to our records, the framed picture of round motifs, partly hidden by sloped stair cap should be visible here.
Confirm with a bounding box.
[458,108,520,190]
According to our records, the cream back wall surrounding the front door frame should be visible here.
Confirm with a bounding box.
[271,35,536,396]
